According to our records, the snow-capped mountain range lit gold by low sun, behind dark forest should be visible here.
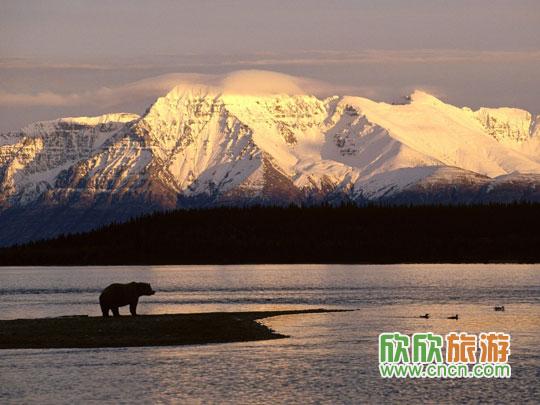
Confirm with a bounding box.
[0,86,540,244]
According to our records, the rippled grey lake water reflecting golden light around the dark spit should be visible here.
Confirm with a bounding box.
[0,265,540,404]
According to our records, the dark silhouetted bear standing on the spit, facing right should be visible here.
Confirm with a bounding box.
[99,282,156,316]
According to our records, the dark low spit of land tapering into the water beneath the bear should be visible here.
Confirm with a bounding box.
[0,308,346,350]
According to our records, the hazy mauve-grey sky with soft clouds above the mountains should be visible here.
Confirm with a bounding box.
[0,0,540,131]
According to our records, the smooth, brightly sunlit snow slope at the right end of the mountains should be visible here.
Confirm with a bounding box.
[345,92,540,177]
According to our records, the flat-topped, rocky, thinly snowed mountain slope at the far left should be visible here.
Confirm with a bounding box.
[0,113,139,204]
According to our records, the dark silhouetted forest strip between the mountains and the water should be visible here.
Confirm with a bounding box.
[0,204,540,266]
